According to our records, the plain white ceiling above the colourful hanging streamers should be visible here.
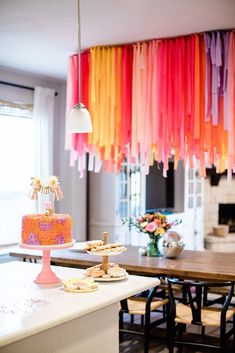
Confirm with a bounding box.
[0,0,235,80]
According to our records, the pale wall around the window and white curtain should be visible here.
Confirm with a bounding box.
[0,67,86,240]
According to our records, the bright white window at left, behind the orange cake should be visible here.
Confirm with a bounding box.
[0,101,35,245]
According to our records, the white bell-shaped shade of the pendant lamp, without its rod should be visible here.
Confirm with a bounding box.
[68,103,92,133]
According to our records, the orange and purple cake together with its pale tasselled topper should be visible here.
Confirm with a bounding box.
[21,176,72,246]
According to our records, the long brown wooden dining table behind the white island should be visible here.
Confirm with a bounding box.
[10,246,235,281]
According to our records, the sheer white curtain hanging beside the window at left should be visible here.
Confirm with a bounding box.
[33,87,55,184]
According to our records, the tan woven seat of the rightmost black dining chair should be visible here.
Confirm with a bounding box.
[175,303,235,326]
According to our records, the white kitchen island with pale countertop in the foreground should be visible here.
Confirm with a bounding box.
[0,262,159,353]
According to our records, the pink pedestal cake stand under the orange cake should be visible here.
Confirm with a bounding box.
[20,240,75,284]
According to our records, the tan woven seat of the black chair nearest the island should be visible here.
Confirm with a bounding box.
[127,297,168,315]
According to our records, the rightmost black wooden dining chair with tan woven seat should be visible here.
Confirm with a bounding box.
[168,278,235,353]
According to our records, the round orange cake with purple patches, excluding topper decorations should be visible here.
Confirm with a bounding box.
[21,213,72,245]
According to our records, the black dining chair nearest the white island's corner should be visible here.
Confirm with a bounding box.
[119,286,169,353]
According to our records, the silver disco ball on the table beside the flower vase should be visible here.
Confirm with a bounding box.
[158,230,185,258]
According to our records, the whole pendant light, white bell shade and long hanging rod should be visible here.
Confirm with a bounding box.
[68,0,92,133]
